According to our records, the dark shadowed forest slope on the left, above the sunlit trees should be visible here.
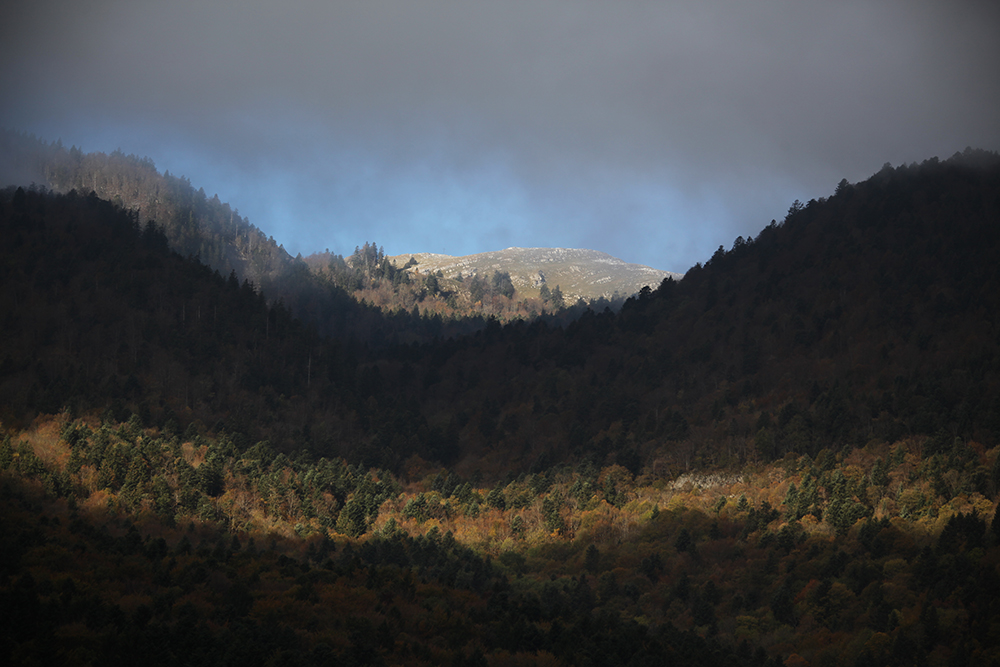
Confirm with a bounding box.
[0,189,351,444]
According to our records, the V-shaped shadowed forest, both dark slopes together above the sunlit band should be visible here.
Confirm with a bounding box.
[0,151,1000,478]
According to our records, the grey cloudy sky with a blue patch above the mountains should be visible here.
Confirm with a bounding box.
[0,0,1000,272]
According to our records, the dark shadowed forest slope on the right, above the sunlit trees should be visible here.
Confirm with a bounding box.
[376,151,1000,474]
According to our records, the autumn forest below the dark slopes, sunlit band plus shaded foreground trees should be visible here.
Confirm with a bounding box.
[0,415,1000,665]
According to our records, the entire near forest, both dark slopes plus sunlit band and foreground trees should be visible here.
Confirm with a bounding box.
[0,151,1000,665]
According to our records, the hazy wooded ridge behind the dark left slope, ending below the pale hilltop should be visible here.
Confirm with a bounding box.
[0,130,668,345]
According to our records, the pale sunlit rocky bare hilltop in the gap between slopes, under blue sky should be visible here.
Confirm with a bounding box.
[389,248,682,303]
